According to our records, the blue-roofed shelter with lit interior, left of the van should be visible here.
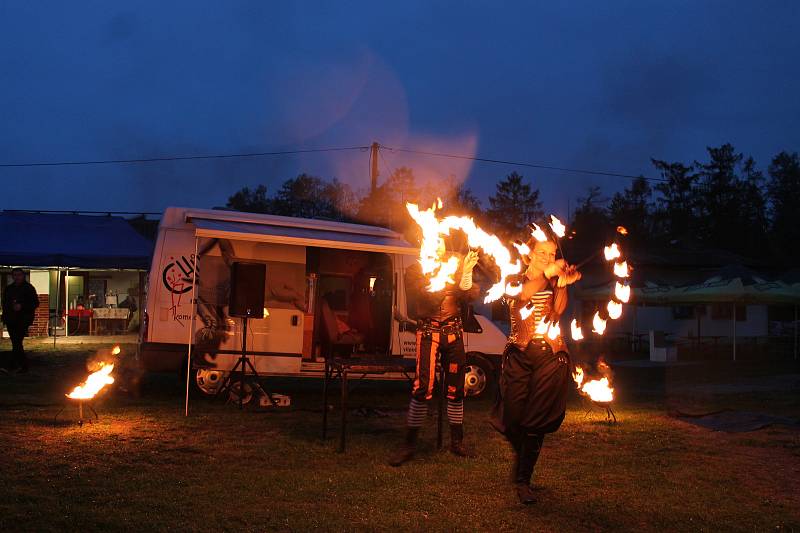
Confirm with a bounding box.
[0,211,153,336]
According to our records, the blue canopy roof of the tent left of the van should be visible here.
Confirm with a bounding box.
[0,211,153,270]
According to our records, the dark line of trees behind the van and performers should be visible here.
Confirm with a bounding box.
[227,144,800,265]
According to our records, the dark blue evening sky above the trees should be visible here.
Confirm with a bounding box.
[0,0,800,213]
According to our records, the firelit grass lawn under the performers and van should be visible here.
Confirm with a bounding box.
[0,341,800,531]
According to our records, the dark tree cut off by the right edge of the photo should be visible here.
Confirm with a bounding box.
[767,152,800,265]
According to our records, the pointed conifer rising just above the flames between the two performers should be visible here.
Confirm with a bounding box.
[486,172,544,239]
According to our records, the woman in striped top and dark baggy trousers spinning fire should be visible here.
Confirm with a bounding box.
[491,234,581,504]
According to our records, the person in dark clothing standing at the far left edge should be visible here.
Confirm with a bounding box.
[3,268,39,372]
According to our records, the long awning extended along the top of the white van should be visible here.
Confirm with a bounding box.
[191,218,419,255]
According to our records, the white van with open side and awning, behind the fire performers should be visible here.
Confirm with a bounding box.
[139,207,506,396]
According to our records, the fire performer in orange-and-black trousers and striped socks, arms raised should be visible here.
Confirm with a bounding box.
[389,240,479,466]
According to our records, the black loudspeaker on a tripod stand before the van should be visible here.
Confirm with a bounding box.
[217,262,275,409]
